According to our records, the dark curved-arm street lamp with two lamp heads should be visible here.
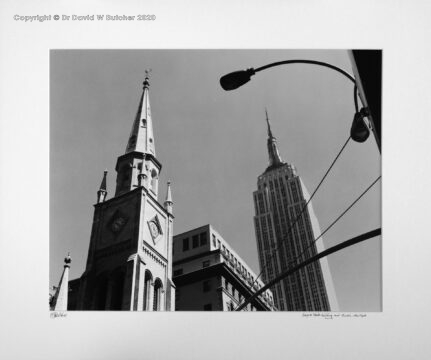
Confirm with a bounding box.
[220,59,380,150]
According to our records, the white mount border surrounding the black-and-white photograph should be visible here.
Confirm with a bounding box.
[0,0,431,359]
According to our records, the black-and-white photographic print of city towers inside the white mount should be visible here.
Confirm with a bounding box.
[49,49,384,312]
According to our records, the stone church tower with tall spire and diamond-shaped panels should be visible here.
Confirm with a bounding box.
[77,73,175,311]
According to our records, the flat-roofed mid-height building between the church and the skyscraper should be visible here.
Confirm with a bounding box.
[173,225,276,311]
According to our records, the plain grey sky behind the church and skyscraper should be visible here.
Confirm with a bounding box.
[49,50,382,311]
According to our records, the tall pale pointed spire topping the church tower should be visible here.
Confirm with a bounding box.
[126,70,156,156]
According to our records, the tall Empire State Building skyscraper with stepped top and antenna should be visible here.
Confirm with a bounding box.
[253,114,338,311]
